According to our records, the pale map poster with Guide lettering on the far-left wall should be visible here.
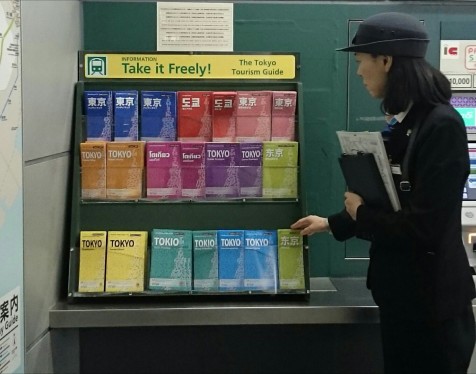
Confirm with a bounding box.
[0,0,24,374]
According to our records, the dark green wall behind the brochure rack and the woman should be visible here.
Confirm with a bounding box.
[83,1,476,276]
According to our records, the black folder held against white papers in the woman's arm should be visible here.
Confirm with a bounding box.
[339,153,393,211]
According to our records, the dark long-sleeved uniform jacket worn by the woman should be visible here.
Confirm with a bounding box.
[329,105,476,321]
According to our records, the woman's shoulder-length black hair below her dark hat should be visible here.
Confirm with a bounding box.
[380,56,451,114]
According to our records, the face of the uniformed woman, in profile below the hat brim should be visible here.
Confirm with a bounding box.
[355,52,392,99]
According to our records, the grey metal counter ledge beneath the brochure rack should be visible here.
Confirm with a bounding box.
[49,278,379,329]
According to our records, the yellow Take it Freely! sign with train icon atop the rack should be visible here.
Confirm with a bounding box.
[83,53,296,79]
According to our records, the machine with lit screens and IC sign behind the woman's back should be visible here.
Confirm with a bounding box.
[440,40,476,269]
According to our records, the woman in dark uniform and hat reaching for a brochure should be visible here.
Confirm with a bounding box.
[291,13,475,373]
